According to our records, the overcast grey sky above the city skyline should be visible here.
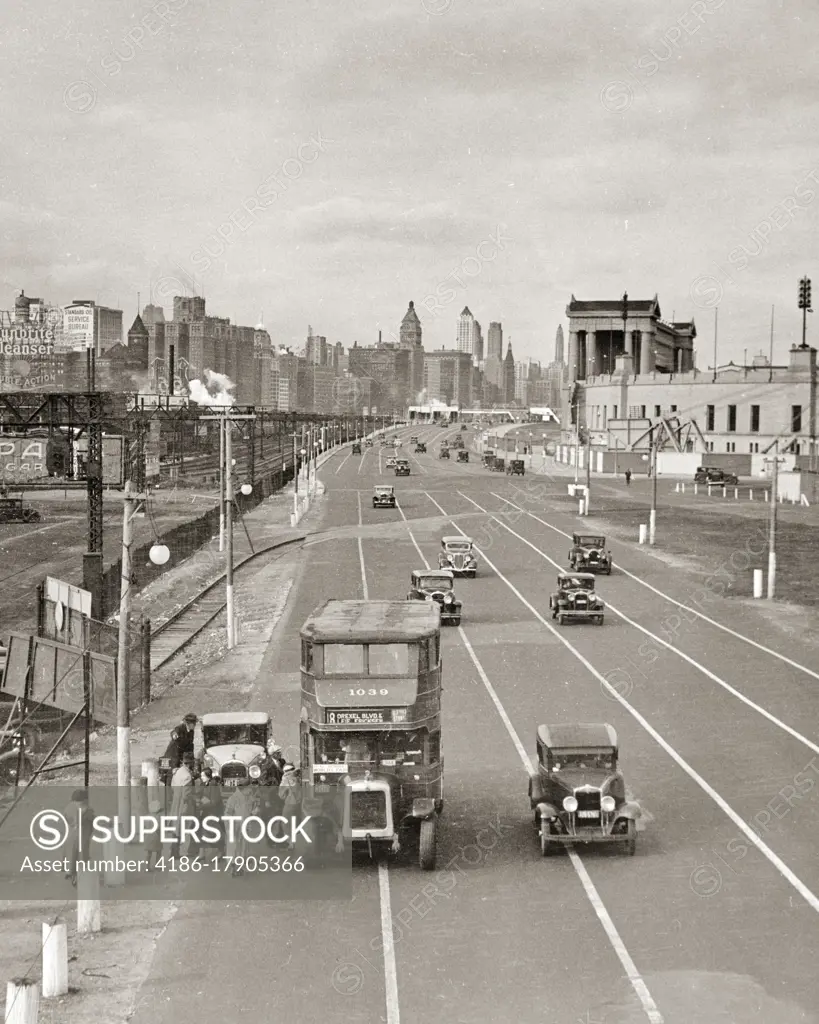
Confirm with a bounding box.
[0,0,819,367]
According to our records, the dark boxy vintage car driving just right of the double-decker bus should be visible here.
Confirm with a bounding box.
[529,722,642,857]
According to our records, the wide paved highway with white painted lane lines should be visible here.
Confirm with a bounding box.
[133,428,819,1024]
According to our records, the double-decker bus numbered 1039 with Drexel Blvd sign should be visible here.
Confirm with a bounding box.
[301,600,443,870]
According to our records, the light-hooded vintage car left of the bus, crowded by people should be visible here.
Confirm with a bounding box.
[197,711,278,786]
